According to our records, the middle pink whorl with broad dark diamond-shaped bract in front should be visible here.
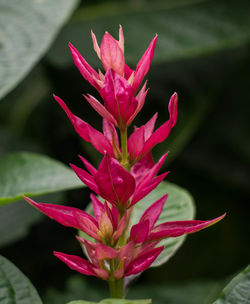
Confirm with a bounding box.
[71,154,168,212]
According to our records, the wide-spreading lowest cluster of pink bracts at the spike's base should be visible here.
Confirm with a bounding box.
[25,194,225,280]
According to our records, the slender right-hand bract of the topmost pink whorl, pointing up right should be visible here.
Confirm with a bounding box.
[133,35,158,91]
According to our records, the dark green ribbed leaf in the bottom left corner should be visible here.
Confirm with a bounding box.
[0,256,42,304]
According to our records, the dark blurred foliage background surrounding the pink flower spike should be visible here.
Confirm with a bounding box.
[0,0,250,303]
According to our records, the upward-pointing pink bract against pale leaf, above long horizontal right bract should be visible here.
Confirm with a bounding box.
[140,194,168,230]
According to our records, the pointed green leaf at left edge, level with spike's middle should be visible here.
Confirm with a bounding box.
[0,152,84,205]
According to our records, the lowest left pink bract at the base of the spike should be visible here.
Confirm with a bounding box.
[54,251,97,276]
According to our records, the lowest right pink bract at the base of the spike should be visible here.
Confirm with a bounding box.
[125,246,164,276]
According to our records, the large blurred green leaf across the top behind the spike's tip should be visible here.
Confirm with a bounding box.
[49,0,250,66]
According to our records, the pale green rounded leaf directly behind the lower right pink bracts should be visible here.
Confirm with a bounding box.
[131,182,195,267]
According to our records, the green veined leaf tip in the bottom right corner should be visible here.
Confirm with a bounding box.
[214,265,250,304]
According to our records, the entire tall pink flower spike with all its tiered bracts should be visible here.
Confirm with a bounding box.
[25,26,224,280]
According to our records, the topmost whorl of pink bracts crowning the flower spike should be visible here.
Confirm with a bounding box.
[69,26,157,128]
